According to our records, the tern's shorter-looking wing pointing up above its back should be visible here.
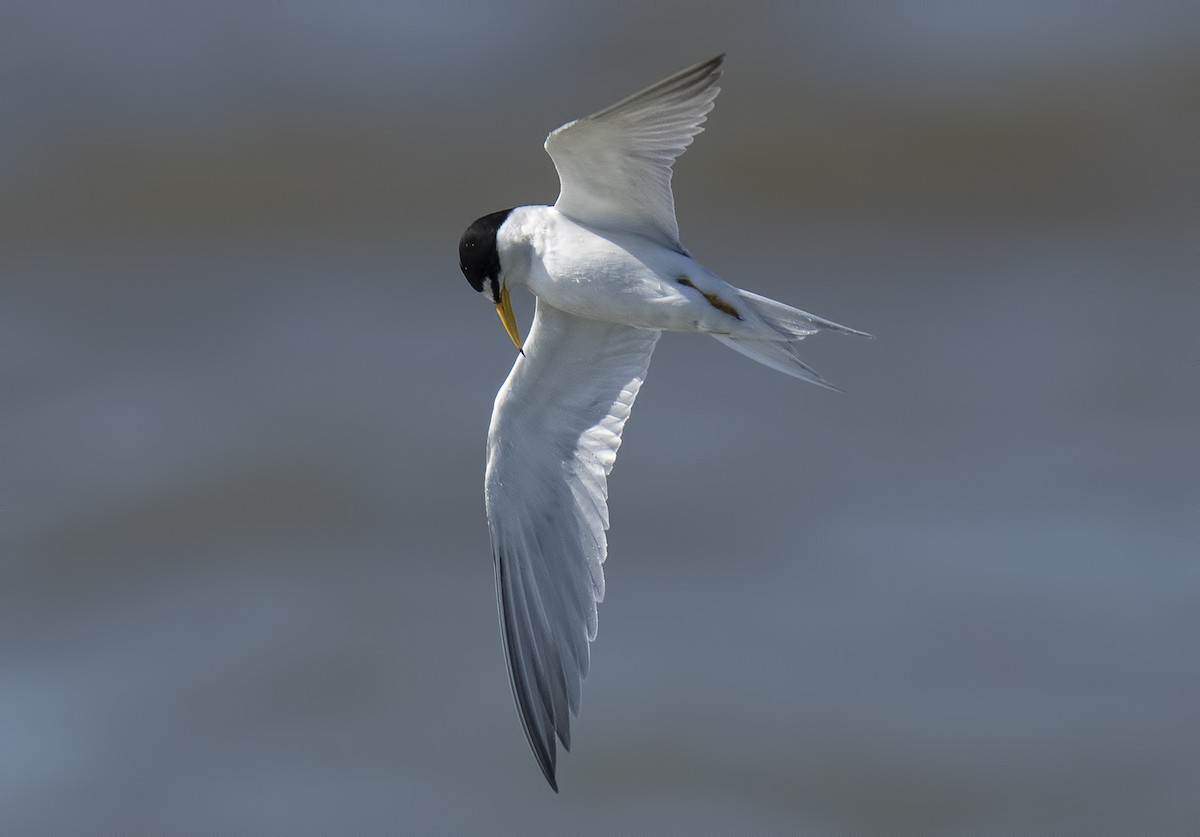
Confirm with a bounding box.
[546,54,725,251]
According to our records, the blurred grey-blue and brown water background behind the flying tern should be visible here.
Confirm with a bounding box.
[0,2,1200,833]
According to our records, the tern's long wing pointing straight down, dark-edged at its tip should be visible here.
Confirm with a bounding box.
[485,300,659,790]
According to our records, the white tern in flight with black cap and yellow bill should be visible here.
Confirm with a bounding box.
[458,55,868,791]
